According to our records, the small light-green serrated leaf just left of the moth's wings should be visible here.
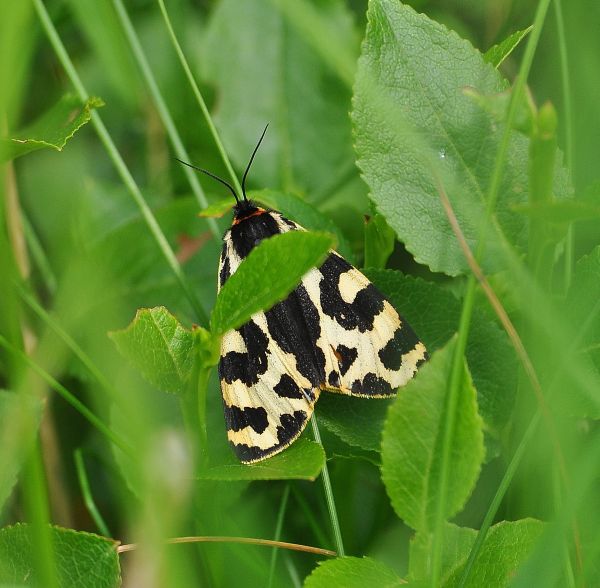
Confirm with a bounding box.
[109,306,198,394]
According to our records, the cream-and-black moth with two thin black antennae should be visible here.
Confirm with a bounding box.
[182,125,427,463]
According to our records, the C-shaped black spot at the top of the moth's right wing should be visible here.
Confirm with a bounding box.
[319,254,384,333]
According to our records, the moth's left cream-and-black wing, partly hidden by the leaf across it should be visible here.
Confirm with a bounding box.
[219,212,322,463]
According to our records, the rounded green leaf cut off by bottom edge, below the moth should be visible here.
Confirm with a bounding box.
[304,557,406,588]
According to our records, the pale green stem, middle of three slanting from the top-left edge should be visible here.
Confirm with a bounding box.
[113,0,221,239]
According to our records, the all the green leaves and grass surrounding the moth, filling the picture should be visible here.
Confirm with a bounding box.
[0,0,600,588]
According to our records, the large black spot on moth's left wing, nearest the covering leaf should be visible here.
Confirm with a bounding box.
[219,321,269,386]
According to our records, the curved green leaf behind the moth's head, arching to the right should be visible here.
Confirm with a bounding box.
[252,190,354,263]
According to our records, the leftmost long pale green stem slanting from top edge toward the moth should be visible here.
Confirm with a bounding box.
[33,0,208,325]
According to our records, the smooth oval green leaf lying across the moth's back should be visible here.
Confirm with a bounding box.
[210,231,334,334]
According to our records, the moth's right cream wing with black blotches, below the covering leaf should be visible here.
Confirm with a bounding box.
[303,251,427,397]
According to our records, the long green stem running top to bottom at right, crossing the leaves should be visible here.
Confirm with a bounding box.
[431,0,550,588]
